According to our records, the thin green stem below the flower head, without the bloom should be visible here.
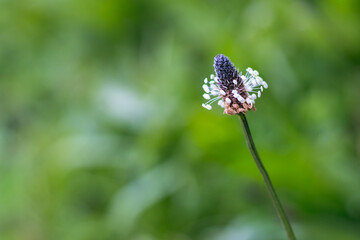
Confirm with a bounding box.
[239,113,296,240]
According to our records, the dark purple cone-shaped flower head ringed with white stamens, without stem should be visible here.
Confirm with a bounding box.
[202,54,268,115]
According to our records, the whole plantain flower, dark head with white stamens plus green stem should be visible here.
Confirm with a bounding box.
[202,54,296,240]
